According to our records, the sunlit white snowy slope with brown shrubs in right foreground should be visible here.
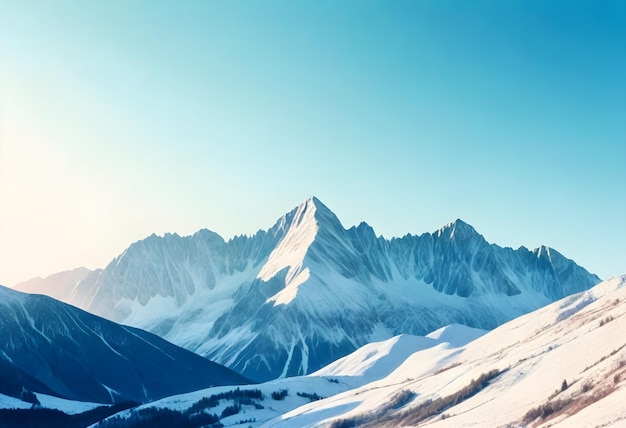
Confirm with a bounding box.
[265,276,626,427]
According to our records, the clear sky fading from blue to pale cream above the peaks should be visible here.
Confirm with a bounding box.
[0,0,626,285]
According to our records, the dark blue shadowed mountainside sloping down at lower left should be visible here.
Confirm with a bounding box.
[0,286,247,403]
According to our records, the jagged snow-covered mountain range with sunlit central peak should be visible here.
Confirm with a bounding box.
[19,198,599,381]
